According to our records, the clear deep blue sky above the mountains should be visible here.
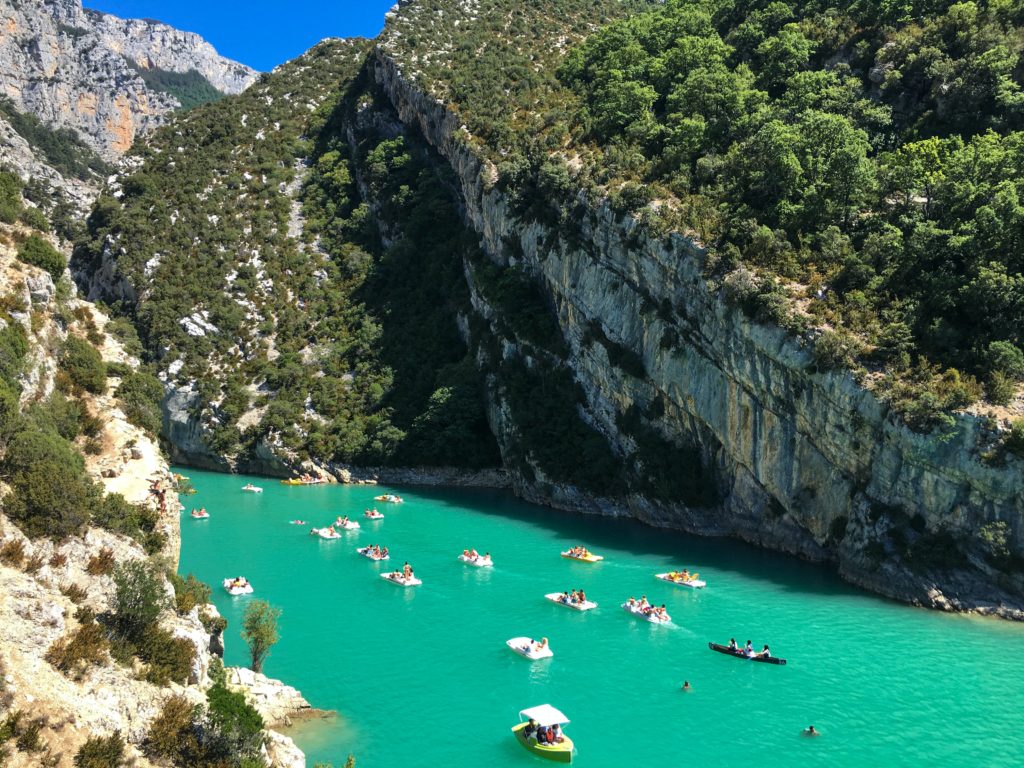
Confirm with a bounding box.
[83,0,395,71]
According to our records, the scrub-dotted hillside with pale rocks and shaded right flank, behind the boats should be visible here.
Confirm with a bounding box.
[76,41,498,467]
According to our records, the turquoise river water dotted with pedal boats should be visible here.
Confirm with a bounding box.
[181,470,1024,768]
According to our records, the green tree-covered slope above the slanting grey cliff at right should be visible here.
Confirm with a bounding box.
[385,0,1024,430]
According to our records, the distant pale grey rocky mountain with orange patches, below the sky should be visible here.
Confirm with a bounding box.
[0,0,256,159]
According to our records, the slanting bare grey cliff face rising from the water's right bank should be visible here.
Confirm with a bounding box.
[374,50,1024,617]
